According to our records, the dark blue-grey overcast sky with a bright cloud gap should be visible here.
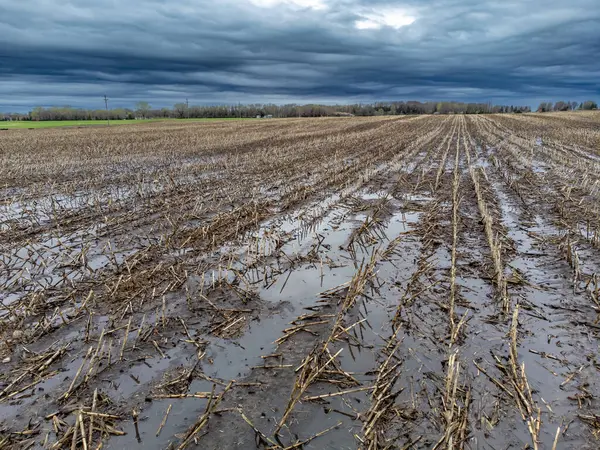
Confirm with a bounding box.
[0,0,600,111]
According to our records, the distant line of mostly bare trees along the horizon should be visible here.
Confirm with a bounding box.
[7,101,597,121]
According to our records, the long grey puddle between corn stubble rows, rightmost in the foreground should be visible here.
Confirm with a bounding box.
[493,178,600,447]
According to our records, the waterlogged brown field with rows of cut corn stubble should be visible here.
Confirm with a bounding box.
[0,112,600,450]
